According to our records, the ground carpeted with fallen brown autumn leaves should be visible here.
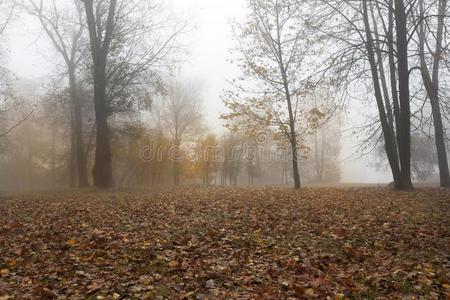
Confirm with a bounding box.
[0,188,450,300]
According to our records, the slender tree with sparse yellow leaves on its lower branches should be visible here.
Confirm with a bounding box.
[224,0,317,189]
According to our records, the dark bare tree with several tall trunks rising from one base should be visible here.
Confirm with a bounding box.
[318,0,412,190]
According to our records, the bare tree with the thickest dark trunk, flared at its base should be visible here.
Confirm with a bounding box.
[84,0,186,187]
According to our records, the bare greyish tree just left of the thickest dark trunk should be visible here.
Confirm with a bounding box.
[24,0,89,187]
